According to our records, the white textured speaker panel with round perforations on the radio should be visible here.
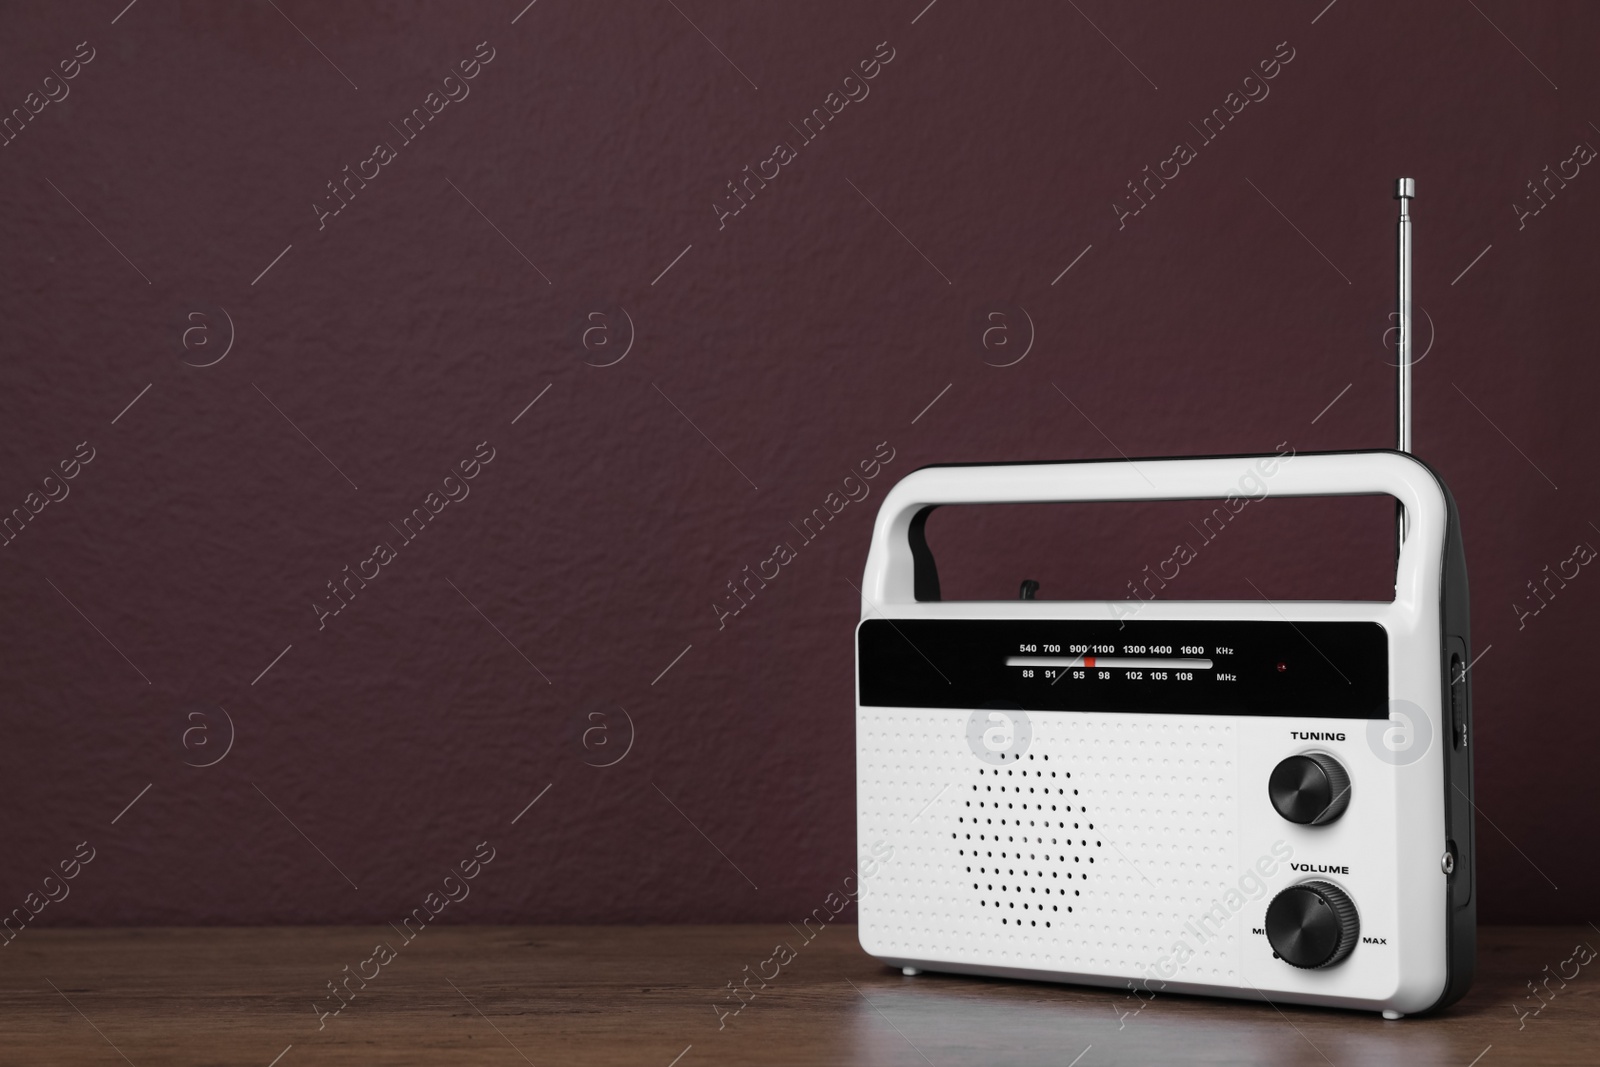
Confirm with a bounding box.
[856,707,1242,985]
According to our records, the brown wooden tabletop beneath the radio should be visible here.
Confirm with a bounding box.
[0,925,1600,1067]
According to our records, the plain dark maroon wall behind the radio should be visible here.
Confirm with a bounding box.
[0,0,1600,925]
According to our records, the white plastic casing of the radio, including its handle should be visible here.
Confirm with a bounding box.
[856,453,1450,1013]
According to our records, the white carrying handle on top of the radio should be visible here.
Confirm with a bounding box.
[861,451,1448,607]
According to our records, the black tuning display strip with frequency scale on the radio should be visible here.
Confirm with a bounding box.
[856,619,1389,718]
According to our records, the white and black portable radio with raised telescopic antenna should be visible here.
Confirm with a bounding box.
[856,179,1477,1019]
